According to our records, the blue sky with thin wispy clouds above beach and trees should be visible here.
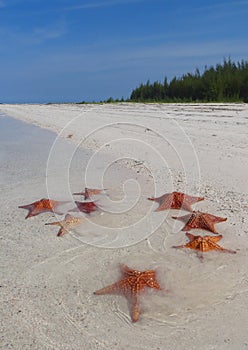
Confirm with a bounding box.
[0,0,248,103]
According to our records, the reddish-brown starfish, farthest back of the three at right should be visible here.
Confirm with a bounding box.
[148,192,204,211]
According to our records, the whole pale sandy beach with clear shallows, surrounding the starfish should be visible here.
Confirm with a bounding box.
[0,103,248,350]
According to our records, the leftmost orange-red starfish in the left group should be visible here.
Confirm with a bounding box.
[18,198,69,219]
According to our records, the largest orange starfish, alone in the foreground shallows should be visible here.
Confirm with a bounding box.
[94,264,161,322]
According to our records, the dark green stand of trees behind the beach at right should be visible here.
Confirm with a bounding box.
[128,59,248,103]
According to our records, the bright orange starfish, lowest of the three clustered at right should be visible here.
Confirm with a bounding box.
[173,232,236,259]
